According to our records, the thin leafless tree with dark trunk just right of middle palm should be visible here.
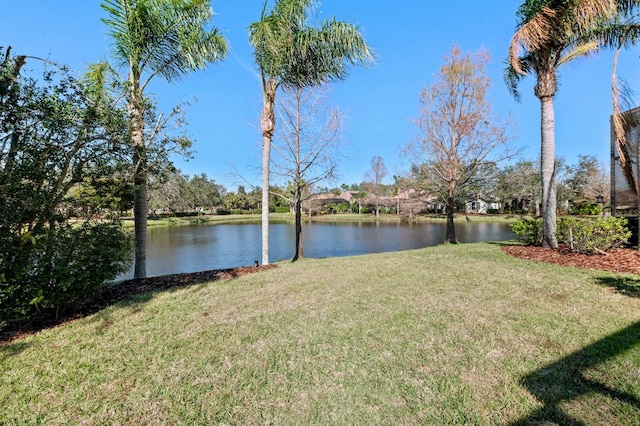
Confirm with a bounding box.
[272,86,342,261]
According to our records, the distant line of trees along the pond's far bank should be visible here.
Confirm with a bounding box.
[138,155,610,216]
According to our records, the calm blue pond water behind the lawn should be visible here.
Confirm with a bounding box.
[120,221,513,278]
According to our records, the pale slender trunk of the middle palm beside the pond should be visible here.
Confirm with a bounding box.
[260,78,277,265]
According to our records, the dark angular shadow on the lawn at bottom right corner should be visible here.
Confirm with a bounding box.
[512,322,640,425]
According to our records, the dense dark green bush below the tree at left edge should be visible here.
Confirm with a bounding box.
[0,223,131,330]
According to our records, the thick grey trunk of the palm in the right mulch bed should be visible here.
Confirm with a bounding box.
[540,96,558,249]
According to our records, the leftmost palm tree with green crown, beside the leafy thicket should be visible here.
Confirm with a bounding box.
[101,0,227,278]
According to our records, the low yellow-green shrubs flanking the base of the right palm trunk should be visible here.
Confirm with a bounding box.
[511,217,631,254]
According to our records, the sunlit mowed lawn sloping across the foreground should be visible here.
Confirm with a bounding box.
[0,243,640,425]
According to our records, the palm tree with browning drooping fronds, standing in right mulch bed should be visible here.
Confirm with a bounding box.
[505,0,617,248]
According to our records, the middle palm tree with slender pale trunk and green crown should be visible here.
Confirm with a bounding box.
[249,0,373,265]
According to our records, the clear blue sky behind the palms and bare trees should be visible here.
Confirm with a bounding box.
[0,0,640,191]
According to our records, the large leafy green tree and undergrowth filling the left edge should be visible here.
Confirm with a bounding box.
[0,52,130,329]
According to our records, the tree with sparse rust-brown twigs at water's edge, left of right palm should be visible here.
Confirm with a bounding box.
[405,46,511,243]
